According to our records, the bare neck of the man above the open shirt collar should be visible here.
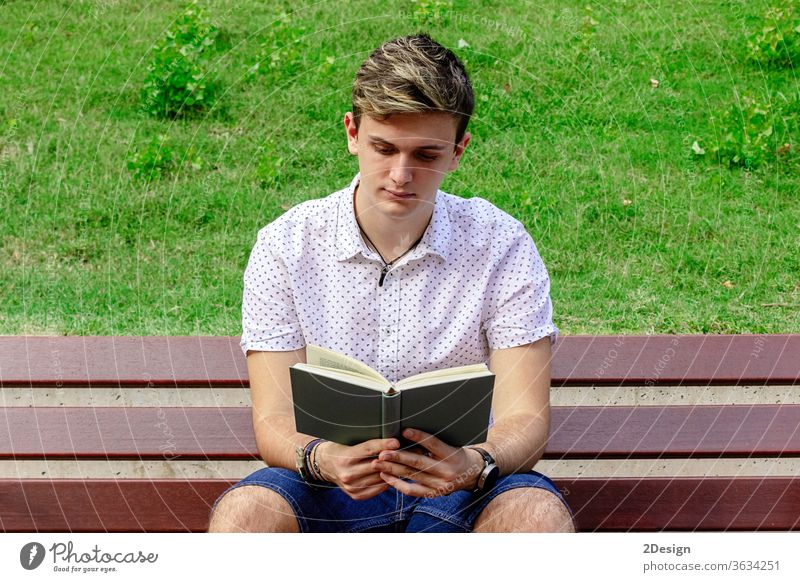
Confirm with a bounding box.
[353,188,433,263]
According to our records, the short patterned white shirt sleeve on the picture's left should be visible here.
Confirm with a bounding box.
[240,226,305,354]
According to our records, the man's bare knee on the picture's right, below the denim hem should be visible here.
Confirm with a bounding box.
[473,488,575,533]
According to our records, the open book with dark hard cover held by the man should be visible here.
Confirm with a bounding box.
[289,344,494,447]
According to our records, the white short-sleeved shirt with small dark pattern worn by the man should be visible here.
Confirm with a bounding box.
[241,175,559,382]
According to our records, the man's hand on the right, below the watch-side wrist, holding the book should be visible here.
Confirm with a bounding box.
[372,429,483,497]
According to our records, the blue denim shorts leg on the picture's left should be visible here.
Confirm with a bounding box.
[214,467,400,532]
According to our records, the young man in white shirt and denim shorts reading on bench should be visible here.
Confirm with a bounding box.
[209,35,573,532]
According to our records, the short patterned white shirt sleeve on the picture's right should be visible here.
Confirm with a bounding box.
[483,223,559,349]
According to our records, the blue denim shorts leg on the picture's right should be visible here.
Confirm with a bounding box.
[406,471,572,532]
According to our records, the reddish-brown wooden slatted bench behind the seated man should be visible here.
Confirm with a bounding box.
[0,335,800,532]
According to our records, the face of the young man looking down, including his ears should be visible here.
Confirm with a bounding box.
[344,112,470,226]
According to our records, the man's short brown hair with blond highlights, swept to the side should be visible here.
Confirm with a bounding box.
[353,34,475,143]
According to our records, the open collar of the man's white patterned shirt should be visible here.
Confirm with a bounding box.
[336,174,451,261]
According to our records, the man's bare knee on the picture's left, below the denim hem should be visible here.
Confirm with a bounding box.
[208,485,299,533]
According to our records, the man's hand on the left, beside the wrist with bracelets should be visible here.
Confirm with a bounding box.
[315,439,400,500]
